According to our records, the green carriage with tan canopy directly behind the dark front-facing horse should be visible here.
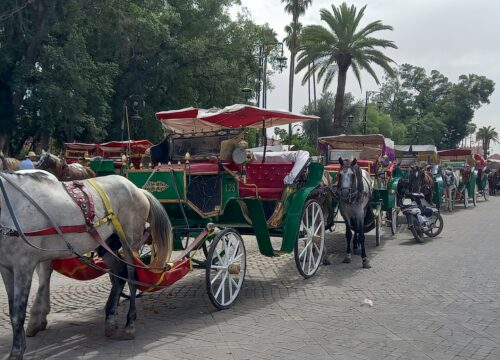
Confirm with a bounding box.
[318,134,399,246]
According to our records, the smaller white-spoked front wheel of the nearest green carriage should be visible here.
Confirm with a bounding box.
[205,228,246,310]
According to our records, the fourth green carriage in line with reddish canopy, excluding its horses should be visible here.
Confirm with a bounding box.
[438,149,479,208]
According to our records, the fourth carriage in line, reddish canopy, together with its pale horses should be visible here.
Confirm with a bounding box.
[438,149,479,211]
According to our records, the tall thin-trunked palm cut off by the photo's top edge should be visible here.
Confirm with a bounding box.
[281,0,312,138]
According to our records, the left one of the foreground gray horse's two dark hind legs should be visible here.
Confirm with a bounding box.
[102,252,126,337]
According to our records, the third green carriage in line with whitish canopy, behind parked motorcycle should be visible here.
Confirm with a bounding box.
[394,145,443,209]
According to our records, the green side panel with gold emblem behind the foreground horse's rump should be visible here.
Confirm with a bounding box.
[127,170,186,201]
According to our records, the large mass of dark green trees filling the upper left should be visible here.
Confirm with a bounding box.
[0,0,276,152]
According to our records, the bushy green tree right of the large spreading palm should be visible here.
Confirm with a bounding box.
[379,64,495,148]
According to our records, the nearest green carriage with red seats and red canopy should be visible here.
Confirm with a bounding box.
[127,105,329,309]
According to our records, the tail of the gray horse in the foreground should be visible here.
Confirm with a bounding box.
[142,190,174,267]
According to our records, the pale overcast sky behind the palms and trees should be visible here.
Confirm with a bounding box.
[231,0,500,152]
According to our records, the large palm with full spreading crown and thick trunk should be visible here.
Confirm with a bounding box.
[295,3,397,134]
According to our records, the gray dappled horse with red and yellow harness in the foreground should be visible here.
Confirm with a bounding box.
[0,173,172,359]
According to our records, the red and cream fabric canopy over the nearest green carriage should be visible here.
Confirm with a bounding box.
[156,104,318,134]
